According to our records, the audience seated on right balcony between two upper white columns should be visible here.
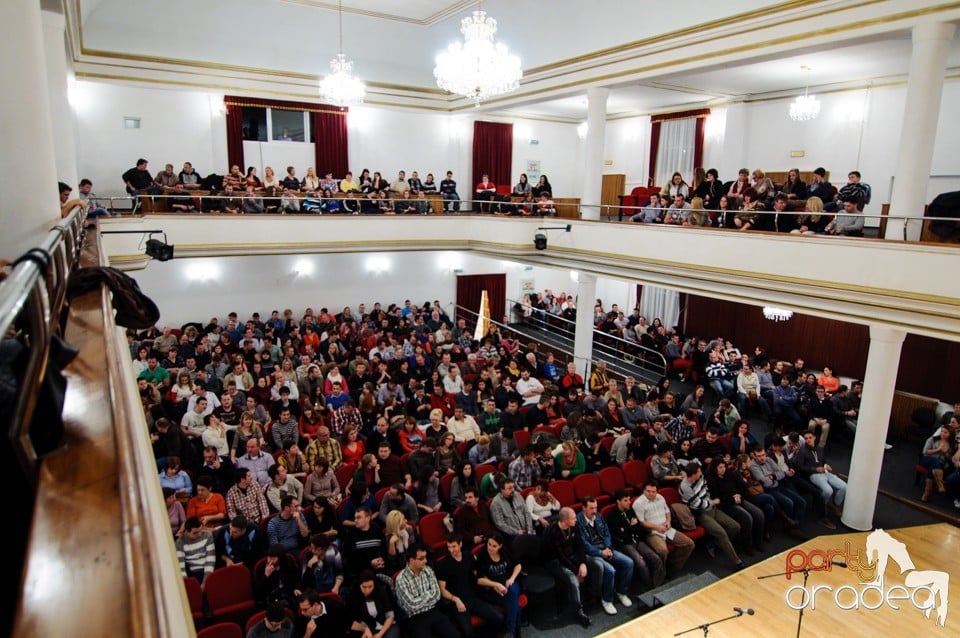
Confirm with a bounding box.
[630,167,872,236]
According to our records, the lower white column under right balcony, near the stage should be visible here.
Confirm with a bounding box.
[841,326,906,531]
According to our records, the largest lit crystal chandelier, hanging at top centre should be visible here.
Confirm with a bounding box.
[433,2,523,106]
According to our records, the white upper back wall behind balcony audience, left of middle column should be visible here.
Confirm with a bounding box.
[71,80,583,198]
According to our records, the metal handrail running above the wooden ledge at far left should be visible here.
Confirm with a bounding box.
[0,208,86,484]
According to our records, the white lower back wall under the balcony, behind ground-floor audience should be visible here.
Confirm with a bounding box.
[130,251,632,326]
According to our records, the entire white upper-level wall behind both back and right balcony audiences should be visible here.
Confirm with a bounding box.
[71,81,960,211]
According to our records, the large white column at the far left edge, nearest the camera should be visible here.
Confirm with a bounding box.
[0,0,60,258]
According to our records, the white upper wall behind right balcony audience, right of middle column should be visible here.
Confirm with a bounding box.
[606,80,960,212]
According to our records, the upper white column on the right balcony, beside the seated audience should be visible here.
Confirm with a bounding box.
[884,22,956,240]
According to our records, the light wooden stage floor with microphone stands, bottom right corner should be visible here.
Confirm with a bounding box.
[603,523,960,638]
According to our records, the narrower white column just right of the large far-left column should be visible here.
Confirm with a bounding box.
[41,11,80,188]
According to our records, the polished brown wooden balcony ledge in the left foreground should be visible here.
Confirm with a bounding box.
[13,232,196,638]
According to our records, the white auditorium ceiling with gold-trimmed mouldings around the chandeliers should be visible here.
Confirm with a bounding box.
[63,0,960,121]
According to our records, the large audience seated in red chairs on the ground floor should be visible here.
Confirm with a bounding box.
[135,291,876,636]
